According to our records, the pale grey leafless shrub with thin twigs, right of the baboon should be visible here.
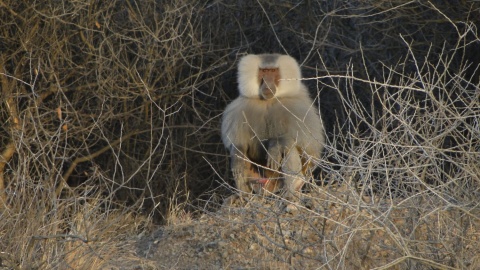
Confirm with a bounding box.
[311,35,480,269]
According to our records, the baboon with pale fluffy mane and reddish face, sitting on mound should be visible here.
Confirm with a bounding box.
[222,54,324,197]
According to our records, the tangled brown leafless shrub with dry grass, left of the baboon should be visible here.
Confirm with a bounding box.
[0,1,225,268]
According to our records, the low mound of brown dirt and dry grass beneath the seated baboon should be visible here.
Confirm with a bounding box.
[104,188,480,269]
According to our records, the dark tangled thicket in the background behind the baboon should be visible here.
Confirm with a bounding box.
[0,0,480,222]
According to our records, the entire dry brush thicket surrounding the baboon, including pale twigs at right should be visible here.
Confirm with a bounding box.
[0,0,480,269]
